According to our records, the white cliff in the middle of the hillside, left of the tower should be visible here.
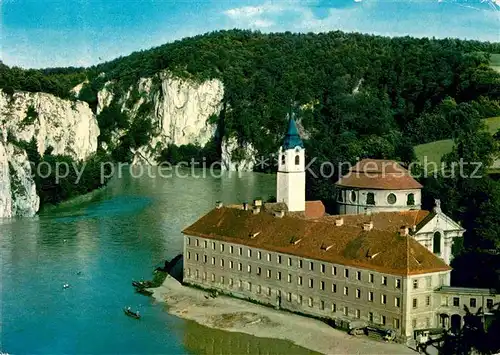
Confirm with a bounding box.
[97,71,228,168]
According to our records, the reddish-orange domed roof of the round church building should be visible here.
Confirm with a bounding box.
[336,159,422,190]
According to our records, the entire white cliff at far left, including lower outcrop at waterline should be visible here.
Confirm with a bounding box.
[0,90,99,218]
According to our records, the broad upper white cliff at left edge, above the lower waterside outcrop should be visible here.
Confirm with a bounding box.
[0,90,99,160]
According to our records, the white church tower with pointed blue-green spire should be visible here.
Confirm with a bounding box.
[276,117,306,212]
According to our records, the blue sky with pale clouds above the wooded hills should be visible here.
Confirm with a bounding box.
[0,0,500,68]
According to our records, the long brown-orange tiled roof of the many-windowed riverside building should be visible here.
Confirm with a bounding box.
[183,207,450,275]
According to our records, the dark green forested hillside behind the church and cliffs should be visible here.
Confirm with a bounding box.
[0,30,500,292]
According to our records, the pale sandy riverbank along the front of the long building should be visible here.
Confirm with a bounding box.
[151,276,415,354]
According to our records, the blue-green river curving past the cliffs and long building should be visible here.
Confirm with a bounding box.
[0,169,316,355]
